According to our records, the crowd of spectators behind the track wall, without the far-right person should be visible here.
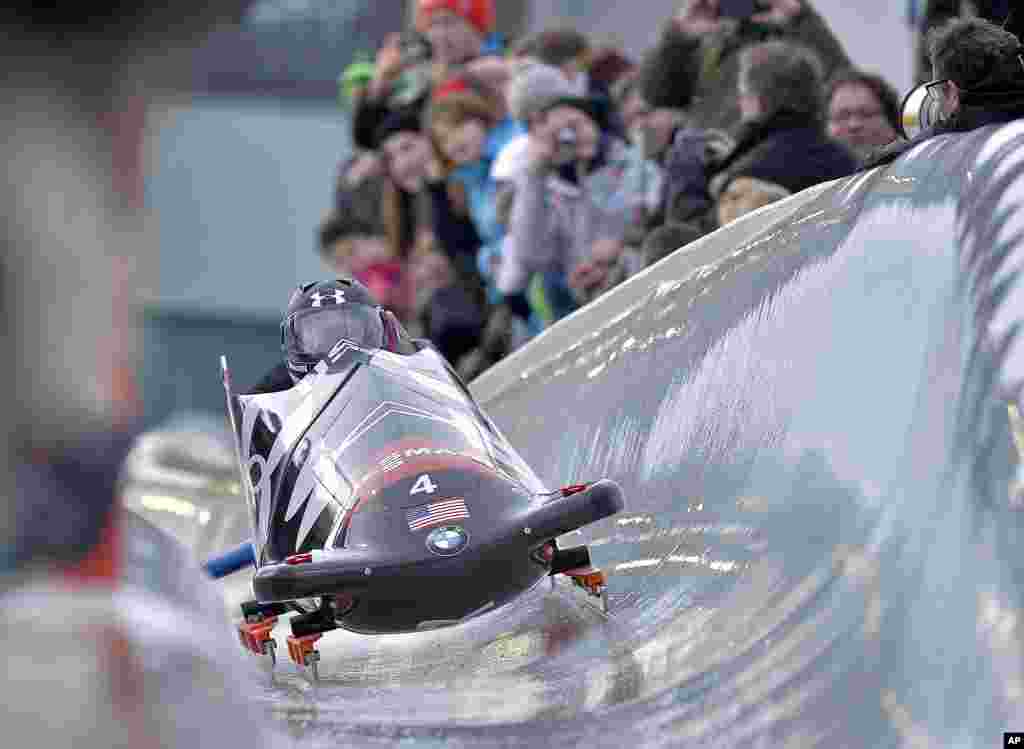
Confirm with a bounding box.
[318,0,1024,379]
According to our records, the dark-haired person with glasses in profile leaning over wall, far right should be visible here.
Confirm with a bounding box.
[868,18,1024,166]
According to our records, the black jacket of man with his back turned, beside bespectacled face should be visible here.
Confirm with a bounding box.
[710,112,857,193]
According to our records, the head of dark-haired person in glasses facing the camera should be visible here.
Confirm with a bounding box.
[825,68,900,158]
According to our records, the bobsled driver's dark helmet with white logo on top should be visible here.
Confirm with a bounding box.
[281,279,404,381]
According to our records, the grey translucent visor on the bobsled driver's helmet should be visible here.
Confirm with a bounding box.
[289,304,384,360]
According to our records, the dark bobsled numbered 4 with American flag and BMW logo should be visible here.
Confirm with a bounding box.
[216,341,624,677]
